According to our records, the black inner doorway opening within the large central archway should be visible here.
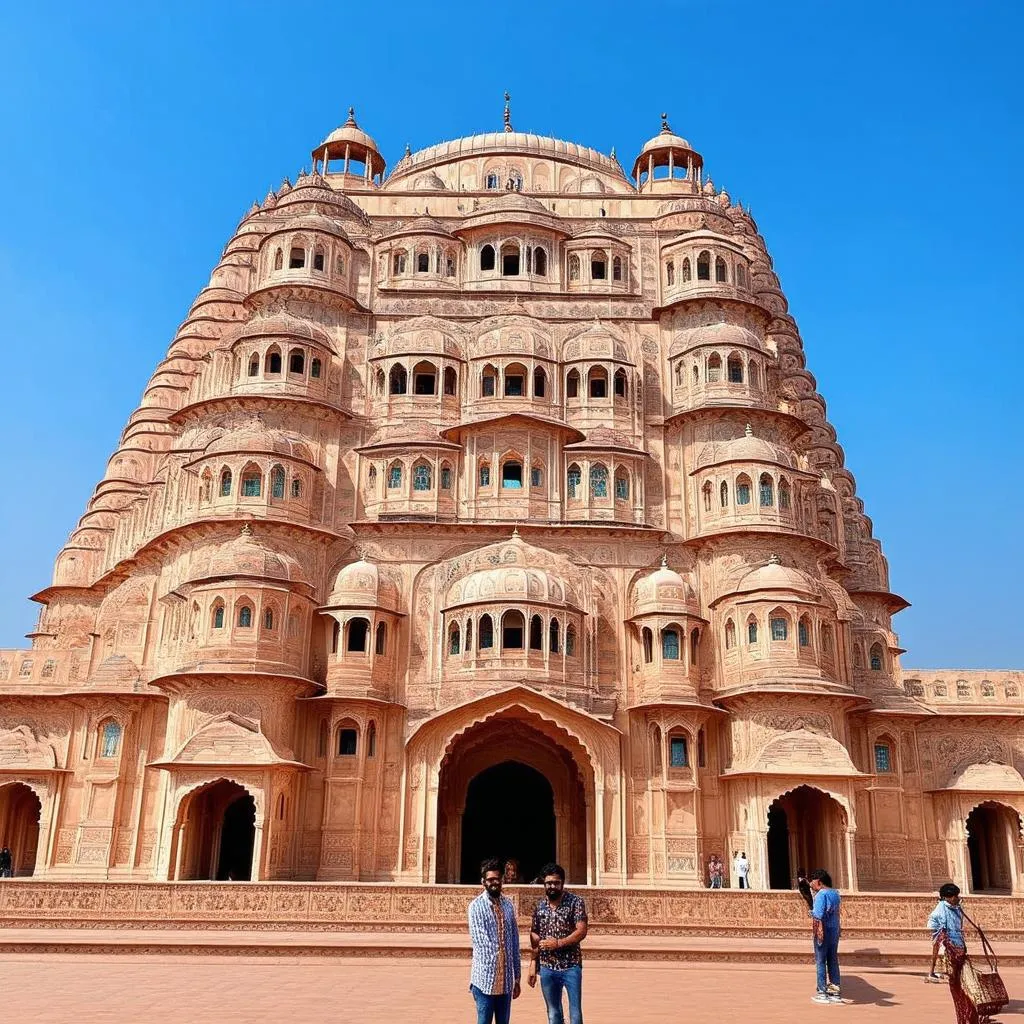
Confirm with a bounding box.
[460,761,555,885]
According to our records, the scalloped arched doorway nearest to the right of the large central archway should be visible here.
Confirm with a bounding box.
[767,785,848,889]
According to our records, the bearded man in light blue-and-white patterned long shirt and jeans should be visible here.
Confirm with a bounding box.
[469,860,520,1024]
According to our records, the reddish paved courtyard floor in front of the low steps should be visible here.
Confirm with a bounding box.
[0,954,1024,1024]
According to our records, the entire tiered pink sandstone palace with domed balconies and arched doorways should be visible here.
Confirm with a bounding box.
[0,117,1024,892]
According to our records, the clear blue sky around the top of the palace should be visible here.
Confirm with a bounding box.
[0,0,1024,668]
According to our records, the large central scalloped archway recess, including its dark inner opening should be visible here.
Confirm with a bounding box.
[436,713,591,885]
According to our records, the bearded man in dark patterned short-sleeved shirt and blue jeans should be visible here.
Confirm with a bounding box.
[526,864,587,1024]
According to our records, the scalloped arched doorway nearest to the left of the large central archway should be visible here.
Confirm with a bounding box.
[175,778,256,882]
